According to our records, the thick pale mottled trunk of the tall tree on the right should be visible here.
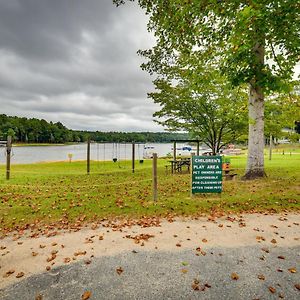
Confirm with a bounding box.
[243,44,266,179]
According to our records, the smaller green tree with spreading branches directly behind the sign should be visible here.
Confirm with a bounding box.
[149,59,247,155]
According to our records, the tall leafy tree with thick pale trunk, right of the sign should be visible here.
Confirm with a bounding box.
[113,0,300,179]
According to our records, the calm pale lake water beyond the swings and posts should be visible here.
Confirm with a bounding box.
[0,143,206,164]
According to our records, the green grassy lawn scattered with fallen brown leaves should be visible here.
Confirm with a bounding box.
[0,151,300,232]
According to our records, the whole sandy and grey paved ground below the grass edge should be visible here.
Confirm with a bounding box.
[0,214,300,299]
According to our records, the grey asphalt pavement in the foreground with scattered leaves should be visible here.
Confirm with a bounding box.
[0,245,300,300]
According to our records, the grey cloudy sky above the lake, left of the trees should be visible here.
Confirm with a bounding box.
[0,0,163,131]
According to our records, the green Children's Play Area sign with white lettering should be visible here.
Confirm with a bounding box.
[192,156,222,194]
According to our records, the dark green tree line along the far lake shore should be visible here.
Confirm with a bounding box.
[0,114,189,143]
